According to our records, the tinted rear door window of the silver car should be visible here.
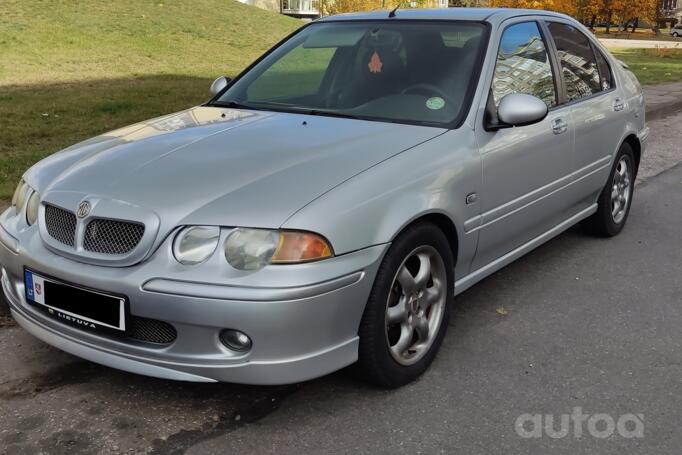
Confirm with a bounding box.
[548,22,602,101]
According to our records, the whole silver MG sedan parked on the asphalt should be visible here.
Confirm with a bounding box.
[0,8,648,387]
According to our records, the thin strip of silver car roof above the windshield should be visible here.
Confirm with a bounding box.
[318,8,571,23]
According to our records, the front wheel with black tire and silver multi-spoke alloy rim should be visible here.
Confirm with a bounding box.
[357,223,454,388]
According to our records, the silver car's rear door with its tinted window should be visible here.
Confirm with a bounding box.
[547,20,626,208]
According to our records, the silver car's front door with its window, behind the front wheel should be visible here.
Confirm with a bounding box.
[473,18,574,269]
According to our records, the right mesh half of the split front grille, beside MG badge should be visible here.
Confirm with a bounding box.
[83,219,144,254]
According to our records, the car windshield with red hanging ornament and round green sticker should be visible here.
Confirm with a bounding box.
[211,20,486,126]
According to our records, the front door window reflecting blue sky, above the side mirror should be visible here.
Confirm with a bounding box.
[492,22,557,107]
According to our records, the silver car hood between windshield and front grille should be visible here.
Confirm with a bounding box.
[26,107,444,239]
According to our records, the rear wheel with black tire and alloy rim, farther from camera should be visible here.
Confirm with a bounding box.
[585,143,637,237]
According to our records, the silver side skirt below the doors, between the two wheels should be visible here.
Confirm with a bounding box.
[455,204,597,295]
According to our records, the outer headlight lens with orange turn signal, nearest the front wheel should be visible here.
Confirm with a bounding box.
[225,228,333,270]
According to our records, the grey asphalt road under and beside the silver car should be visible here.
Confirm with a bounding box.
[0,116,682,454]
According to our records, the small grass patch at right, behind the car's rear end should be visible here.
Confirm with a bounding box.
[612,49,682,84]
